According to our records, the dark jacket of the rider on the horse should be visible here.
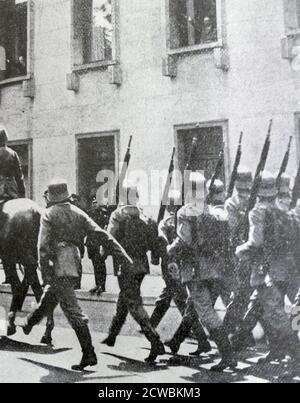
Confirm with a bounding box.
[0,146,25,199]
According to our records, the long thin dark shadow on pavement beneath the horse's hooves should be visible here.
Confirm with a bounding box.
[0,336,71,354]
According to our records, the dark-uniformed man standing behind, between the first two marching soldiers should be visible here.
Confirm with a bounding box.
[86,197,111,295]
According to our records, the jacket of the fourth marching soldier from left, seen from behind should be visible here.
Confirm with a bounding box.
[169,205,228,281]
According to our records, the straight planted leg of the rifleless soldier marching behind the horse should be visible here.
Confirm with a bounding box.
[53,279,97,370]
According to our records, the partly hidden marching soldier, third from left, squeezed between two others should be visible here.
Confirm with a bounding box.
[150,192,211,355]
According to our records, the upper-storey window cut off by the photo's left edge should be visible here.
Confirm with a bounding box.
[0,0,28,80]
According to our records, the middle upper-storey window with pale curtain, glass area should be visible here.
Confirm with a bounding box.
[73,0,115,66]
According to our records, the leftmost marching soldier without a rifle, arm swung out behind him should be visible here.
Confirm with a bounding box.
[23,180,132,370]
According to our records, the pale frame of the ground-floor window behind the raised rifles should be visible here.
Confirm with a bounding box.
[173,119,231,184]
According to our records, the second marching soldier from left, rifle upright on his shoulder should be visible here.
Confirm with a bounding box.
[103,184,165,363]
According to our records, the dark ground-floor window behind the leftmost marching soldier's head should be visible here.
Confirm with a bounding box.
[77,133,117,209]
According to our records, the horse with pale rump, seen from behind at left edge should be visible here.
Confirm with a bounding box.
[0,198,54,345]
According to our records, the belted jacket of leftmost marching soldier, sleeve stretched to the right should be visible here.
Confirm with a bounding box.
[38,202,124,277]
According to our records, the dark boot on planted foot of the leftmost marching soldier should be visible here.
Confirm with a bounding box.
[72,325,97,371]
